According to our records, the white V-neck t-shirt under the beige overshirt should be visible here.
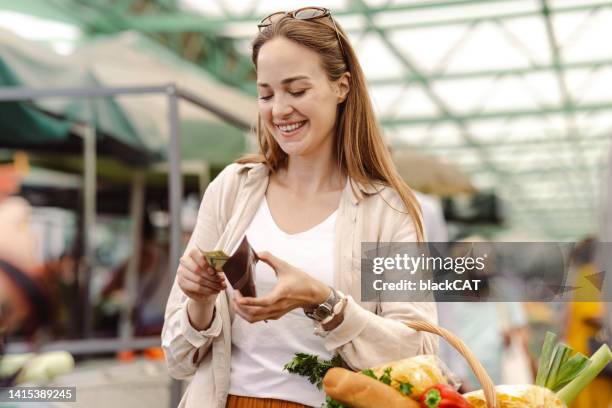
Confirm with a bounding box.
[229,197,337,407]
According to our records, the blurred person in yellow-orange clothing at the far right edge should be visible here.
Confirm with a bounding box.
[565,237,612,408]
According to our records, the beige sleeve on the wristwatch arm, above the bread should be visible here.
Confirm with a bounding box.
[324,191,438,370]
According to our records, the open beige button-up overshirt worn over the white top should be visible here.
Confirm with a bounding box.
[162,164,437,408]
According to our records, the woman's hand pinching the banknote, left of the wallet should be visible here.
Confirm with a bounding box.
[176,248,227,303]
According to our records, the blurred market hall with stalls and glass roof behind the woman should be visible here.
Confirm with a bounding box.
[0,0,612,408]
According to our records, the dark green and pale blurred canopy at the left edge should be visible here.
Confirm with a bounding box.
[0,27,157,157]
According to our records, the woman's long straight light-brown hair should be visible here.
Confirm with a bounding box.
[237,11,424,241]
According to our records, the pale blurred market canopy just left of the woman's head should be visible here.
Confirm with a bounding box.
[76,32,257,167]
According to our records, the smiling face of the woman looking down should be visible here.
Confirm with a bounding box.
[257,37,348,156]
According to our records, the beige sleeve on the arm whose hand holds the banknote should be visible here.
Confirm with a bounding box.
[161,165,236,379]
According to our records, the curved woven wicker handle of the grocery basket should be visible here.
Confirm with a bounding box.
[406,320,500,408]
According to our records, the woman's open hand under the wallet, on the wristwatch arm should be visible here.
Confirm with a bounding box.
[233,251,330,323]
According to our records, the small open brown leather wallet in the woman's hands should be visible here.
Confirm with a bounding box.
[222,235,259,297]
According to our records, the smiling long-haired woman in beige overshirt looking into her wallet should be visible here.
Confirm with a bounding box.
[162,8,437,407]
